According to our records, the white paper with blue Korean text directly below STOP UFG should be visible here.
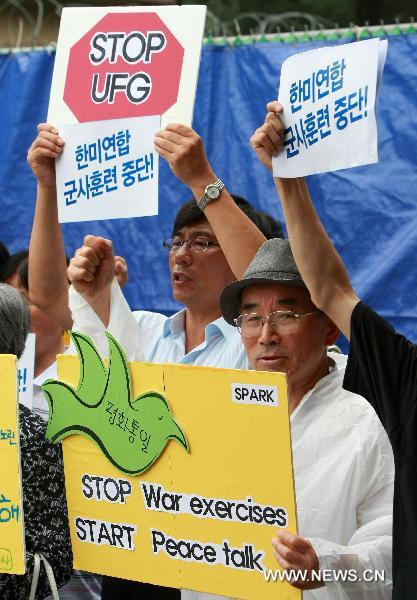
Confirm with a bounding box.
[56,117,160,223]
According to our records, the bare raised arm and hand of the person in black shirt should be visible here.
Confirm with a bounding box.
[251,102,359,339]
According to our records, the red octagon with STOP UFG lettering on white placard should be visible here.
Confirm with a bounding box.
[64,13,184,123]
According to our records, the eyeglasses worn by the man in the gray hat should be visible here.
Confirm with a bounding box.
[235,310,320,337]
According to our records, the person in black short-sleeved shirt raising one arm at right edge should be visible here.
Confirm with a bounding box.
[251,102,417,600]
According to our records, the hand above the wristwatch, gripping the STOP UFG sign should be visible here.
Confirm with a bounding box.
[155,123,216,188]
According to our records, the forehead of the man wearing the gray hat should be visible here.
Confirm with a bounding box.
[240,283,314,311]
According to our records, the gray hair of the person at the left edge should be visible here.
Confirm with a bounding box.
[0,283,30,358]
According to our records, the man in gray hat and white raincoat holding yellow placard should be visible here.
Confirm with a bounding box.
[193,239,394,600]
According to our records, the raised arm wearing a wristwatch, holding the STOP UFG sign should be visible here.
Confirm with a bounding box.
[155,124,265,279]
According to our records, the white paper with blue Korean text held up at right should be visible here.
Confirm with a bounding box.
[272,39,387,177]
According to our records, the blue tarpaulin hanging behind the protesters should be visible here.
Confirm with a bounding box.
[0,35,417,350]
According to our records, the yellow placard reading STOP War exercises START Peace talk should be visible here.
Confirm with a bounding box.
[57,350,301,600]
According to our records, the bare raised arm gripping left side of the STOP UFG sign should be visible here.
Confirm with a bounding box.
[28,123,72,329]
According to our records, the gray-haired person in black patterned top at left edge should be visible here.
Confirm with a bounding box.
[0,284,72,600]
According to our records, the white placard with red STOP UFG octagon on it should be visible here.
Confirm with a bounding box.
[48,6,207,128]
